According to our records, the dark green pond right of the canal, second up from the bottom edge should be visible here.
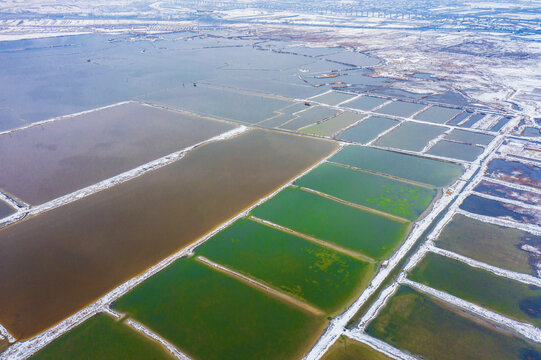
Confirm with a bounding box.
[408,253,541,327]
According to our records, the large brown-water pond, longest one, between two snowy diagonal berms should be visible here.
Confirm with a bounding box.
[0,130,336,339]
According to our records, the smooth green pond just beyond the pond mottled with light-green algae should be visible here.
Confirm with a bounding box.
[253,187,409,260]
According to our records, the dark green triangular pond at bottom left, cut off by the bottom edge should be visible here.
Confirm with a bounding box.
[30,313,175,360]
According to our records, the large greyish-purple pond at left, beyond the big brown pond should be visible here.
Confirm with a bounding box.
[0,103,234,204]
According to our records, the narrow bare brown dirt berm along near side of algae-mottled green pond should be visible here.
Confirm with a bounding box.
[196,256,324,316]
